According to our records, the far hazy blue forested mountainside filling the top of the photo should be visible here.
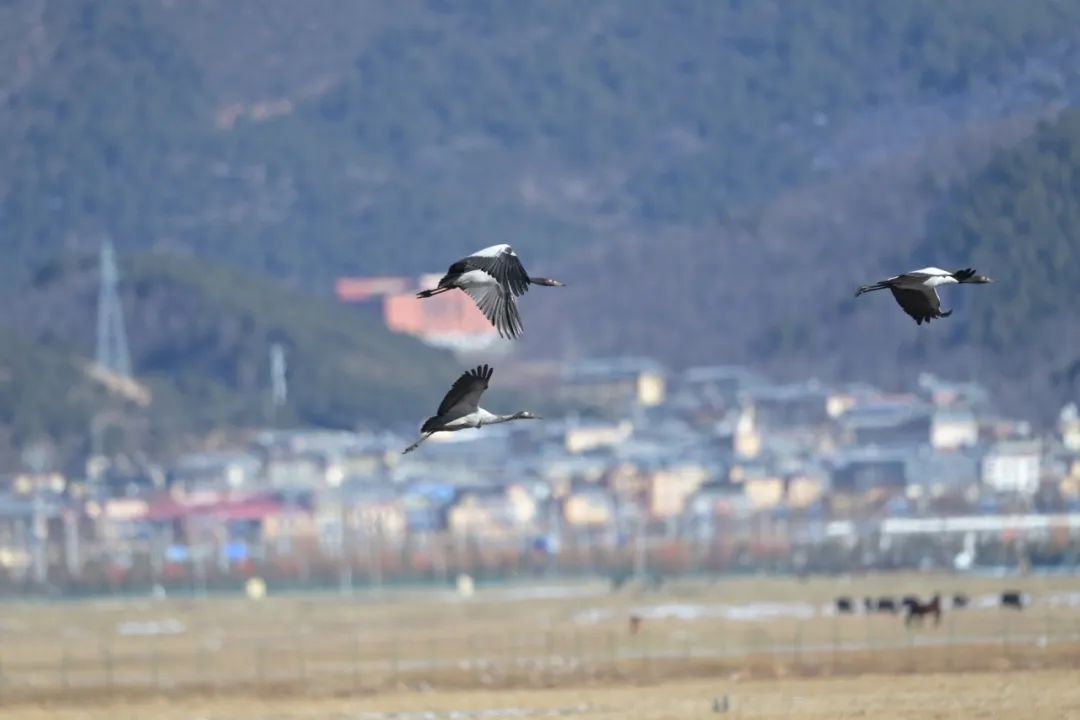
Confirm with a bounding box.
[8,0,1080,289]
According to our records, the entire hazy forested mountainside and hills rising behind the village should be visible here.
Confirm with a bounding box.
[0,0,1080,451]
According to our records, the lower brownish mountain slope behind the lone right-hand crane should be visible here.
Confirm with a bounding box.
[526,111,1080,419]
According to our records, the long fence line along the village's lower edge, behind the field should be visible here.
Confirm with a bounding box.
[8,516,1080,597]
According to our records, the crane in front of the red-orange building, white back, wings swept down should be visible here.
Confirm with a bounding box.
[416,244,565,338]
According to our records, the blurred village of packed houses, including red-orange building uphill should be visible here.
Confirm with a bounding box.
[0,267,1080,595]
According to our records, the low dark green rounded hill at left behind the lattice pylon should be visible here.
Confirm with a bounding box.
[0,250,456,464]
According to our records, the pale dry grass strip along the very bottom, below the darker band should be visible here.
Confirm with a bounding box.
[14,670,1080,720]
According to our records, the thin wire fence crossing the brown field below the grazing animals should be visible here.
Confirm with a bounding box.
[0,604,1080,705]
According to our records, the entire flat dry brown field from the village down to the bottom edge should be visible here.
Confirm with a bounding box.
[0,575,1080,720]
